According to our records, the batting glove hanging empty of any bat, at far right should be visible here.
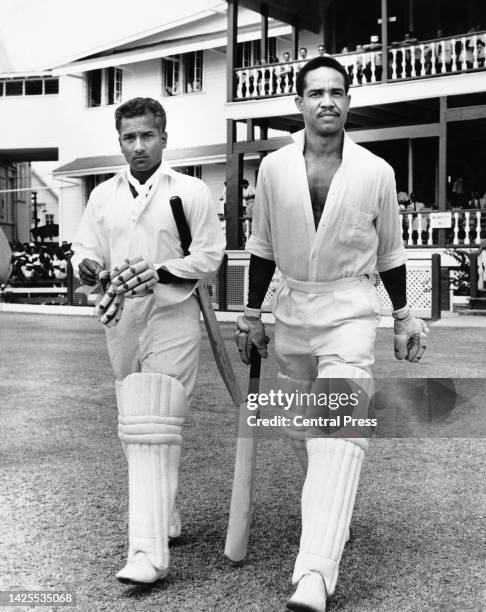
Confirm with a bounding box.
[392,306,429,363]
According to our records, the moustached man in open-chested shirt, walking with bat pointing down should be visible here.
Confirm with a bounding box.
[237,56,428,612]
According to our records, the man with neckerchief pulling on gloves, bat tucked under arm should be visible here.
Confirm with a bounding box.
[72,98,225,583]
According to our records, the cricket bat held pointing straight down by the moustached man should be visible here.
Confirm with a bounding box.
[224,350,261,562]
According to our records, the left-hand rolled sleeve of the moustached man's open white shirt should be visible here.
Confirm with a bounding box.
[246,159,275,261]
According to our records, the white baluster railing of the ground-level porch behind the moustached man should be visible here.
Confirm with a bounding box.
[241,210,486,248]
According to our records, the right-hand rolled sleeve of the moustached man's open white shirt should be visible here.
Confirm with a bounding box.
[376,167,407,272]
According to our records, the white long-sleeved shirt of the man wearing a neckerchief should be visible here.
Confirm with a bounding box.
[72,162,226,305]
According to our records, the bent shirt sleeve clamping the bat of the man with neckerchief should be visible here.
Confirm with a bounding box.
[157,183,226,280]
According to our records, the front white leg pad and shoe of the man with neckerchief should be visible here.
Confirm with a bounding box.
[117,373,187,583]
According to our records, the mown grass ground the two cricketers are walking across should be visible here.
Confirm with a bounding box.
[0,313,486,612]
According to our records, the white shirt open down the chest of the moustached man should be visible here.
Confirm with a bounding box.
[246,130,407,282]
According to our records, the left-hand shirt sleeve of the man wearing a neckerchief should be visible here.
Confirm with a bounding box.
[71,191,106,278]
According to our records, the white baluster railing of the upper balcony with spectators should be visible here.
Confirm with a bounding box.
[235,31,486,100]
